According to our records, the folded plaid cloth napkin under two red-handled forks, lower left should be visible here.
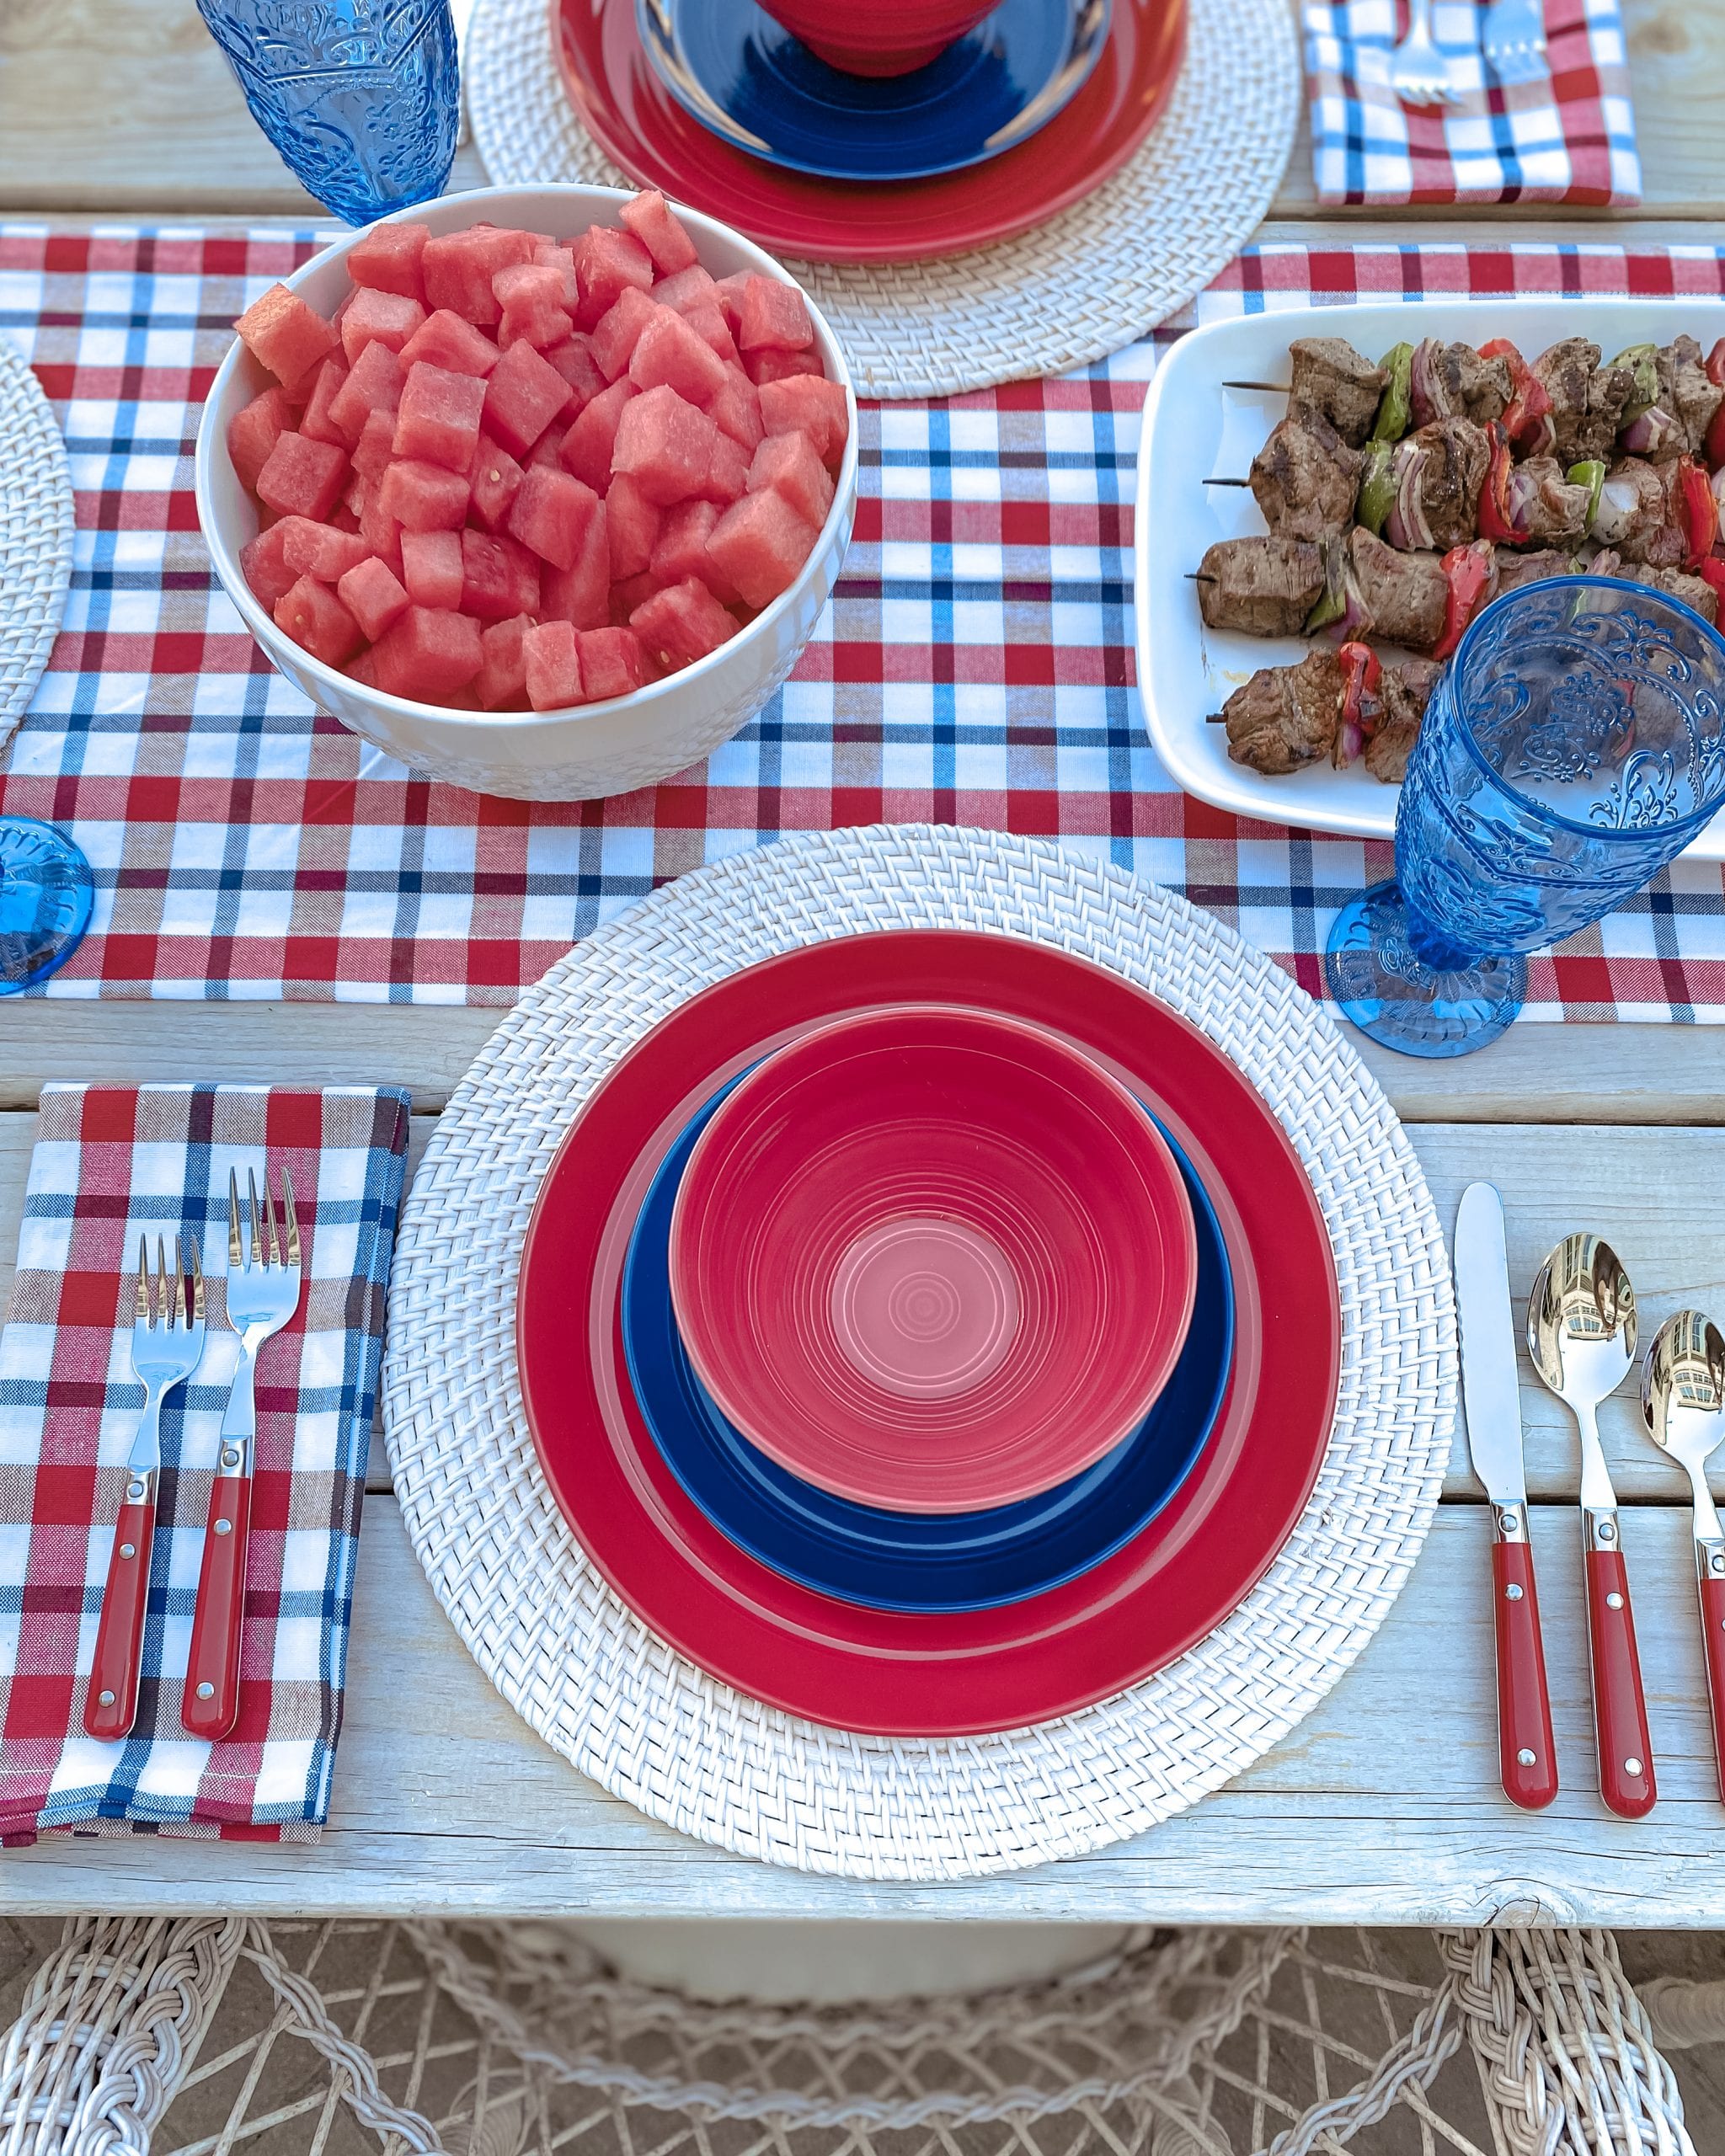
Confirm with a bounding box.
[0,1085,408,1845]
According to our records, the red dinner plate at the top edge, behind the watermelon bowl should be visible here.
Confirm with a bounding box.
[552,0,1186,263]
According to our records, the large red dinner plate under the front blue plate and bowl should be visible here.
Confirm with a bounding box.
[517,929,1341,1736]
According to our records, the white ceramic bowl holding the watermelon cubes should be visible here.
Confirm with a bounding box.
[196,188,856,802]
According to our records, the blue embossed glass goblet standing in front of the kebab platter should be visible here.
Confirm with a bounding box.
[1324,576,1725,1056]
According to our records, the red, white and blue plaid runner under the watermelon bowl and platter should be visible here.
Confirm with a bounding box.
[0,224,1725,1022]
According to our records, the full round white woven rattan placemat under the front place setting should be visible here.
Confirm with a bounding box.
[384,825,1455,1878]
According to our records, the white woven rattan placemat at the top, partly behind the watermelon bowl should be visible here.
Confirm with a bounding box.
[466,0,1300,397]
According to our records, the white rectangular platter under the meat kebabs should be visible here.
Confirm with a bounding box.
[1135,300,1725,860]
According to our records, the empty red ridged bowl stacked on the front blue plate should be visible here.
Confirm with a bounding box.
[670,1007,1197,1512]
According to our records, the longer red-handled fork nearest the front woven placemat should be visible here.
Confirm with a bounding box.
[179,1169,300,1740]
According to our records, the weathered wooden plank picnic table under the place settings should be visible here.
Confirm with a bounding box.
[0,0,1725,1928]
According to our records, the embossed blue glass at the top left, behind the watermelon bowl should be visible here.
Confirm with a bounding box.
[199,0,462,224]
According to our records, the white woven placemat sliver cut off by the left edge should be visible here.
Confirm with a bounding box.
[0,336,73,748]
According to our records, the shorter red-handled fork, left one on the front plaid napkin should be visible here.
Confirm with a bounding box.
[84,1235,203,1740]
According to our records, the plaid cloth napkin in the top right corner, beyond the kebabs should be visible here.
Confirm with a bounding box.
[1305,0,1641,203]
